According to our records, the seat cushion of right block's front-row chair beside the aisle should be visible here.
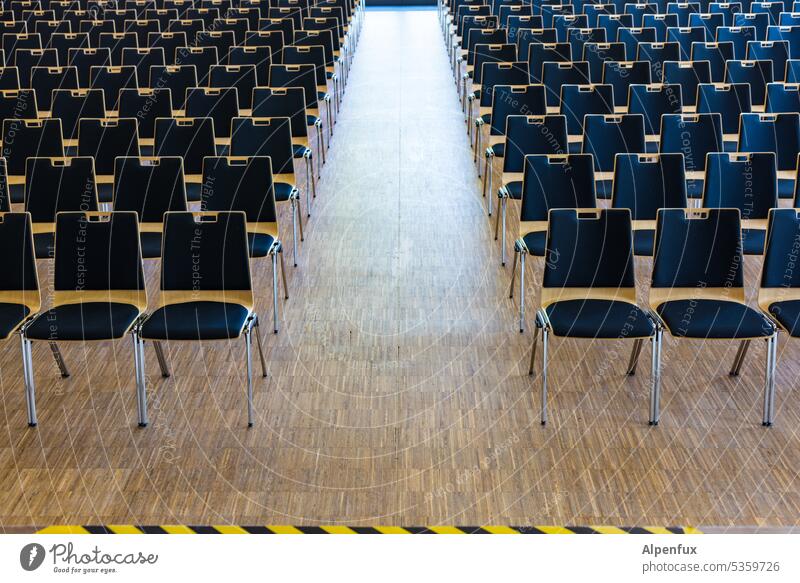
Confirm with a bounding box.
[545,300,655,338]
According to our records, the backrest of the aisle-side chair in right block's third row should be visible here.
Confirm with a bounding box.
[503,115,569,173]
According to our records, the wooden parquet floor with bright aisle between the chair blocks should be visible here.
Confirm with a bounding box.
[0,11,800,529]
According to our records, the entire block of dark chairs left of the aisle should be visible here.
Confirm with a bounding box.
[0,0,364,426]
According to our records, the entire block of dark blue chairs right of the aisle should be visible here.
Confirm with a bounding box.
[440,0,800,425]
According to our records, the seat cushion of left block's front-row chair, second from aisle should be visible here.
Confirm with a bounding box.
[25,302,139,341]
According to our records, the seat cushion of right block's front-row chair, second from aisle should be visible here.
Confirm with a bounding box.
[657,299,774,339]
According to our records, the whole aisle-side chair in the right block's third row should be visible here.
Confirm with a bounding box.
[489,115,569,265]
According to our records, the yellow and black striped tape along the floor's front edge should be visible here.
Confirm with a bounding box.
[37,524,700,534]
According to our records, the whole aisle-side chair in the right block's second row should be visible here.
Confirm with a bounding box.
[509,154,597,332]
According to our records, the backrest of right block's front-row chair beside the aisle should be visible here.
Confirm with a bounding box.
[540,208,636,308]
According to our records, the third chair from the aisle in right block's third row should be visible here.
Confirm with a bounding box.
[659,113,724,198]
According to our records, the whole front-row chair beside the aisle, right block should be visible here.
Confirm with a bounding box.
[529,209,659,425]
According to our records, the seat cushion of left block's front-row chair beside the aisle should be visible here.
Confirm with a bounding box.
[141,301,249,340]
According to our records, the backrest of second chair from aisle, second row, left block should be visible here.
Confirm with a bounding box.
[114,156,187,228]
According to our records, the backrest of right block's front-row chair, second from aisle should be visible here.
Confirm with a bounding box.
[649,209,744,309]
